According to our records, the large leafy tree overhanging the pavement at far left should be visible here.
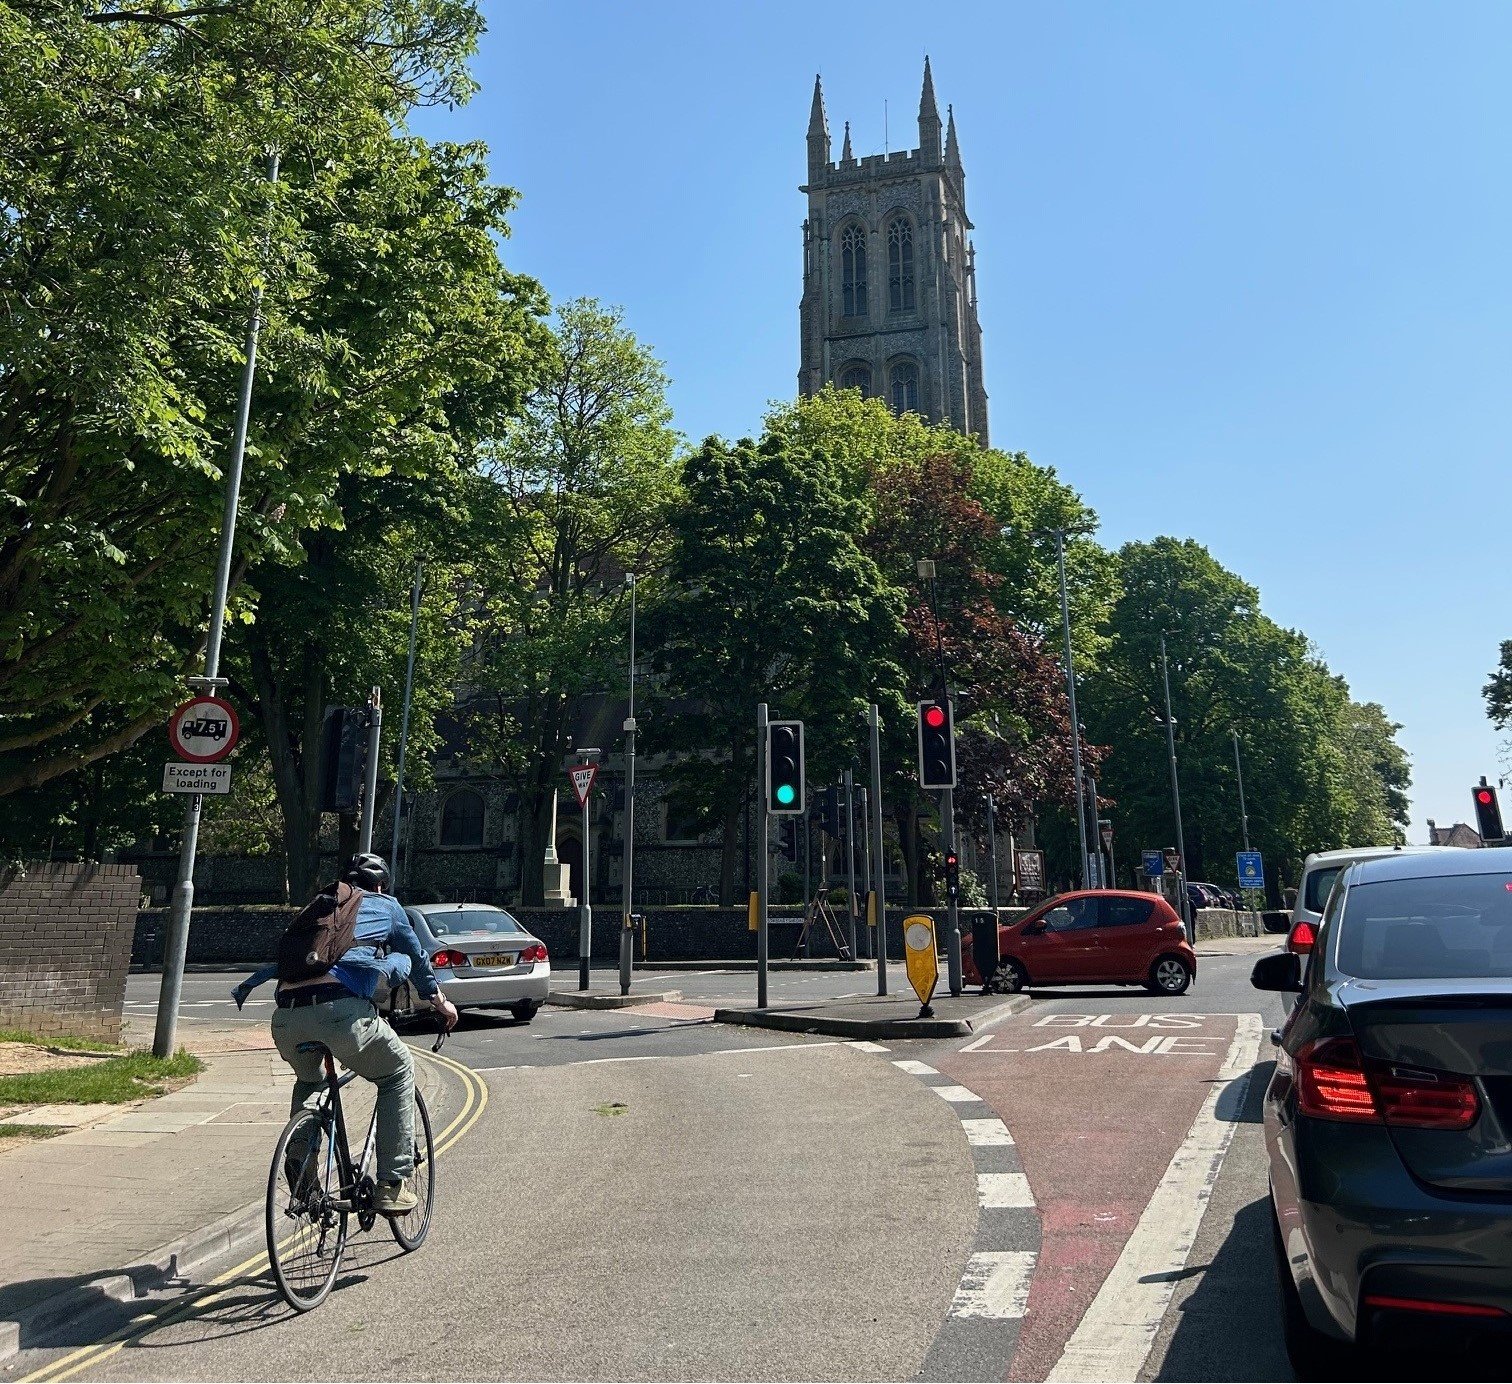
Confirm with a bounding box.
[0,0,511,796]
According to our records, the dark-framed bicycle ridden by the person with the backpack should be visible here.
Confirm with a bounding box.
[265,1029,446,1311]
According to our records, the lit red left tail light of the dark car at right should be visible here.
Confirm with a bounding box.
[1296,1038,1480,1130]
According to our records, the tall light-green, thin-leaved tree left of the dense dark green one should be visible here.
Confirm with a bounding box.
[464,299,677,903]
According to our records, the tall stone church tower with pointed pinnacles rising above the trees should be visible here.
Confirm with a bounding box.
[798,57,987,446]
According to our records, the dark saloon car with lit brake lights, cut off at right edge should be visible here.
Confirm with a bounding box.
[1252,850,1512,1378]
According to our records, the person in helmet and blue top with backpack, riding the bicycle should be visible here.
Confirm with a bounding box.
[231,853,457,1216]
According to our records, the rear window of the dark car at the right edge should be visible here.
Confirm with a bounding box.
[1338,861,1512,980]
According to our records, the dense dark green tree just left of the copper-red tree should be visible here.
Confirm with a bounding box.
[653,434,907,903]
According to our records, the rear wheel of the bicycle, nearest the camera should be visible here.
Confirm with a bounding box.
[266,1110,346,1311]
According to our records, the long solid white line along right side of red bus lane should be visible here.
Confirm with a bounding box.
[1046,1013,1261,1379]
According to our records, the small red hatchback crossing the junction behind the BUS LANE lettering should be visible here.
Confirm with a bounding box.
[963,889,1198,995]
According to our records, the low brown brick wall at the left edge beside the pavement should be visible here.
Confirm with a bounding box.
[0,864,142,1042]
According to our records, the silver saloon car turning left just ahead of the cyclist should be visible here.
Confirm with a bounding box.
[389,903,552,1024]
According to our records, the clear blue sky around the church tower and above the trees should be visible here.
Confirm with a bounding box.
[419,0,1512,839]
